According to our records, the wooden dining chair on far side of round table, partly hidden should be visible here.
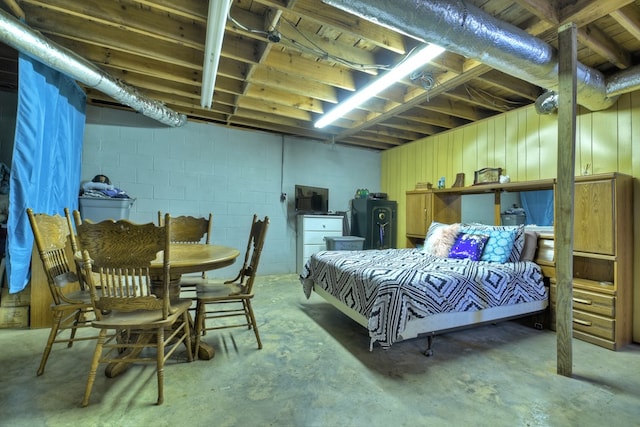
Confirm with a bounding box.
[158,211,213,300]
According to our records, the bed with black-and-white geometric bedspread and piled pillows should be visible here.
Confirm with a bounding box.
[300,223,548,355]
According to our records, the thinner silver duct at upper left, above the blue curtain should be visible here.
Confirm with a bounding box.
[0,10,187,127]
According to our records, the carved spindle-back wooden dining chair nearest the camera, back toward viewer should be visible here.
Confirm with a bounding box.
[74,215,193,406]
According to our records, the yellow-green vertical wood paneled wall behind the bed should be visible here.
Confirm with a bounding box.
[380,91,640,342]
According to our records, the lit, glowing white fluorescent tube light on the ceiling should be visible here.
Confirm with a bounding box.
[314,44,444,128]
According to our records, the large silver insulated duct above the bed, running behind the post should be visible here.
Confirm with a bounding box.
[323,0,616,111]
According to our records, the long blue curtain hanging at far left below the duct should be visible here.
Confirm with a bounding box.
[7,53,86,293]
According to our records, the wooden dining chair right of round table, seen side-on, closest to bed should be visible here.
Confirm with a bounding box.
[194,215,269,354]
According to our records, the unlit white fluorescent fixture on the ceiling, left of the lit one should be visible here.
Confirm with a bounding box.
[200,0,231,108]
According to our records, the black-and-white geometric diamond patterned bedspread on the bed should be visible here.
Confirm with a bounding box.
[300,249,548,347]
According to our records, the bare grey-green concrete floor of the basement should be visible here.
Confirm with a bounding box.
[0,275,640,427]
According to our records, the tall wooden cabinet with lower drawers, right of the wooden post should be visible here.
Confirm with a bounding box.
[551,173,633,350]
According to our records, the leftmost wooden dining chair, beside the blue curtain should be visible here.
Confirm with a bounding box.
[27,208,97,375]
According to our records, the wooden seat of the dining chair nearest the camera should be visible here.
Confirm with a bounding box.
[91,299,191,330]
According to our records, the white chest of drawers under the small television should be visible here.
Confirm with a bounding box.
[296,215,343,274]
